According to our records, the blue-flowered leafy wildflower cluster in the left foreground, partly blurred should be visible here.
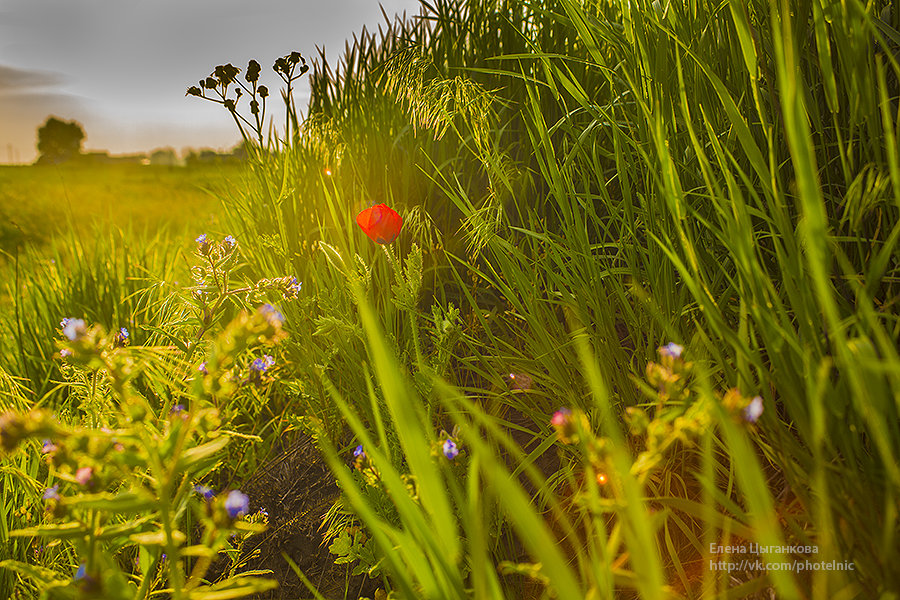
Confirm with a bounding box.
[0,235,300,597]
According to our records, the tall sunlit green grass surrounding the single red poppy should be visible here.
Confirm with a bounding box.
[0,0,900,599]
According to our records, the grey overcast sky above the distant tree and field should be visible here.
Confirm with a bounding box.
[0,0,419,163]
